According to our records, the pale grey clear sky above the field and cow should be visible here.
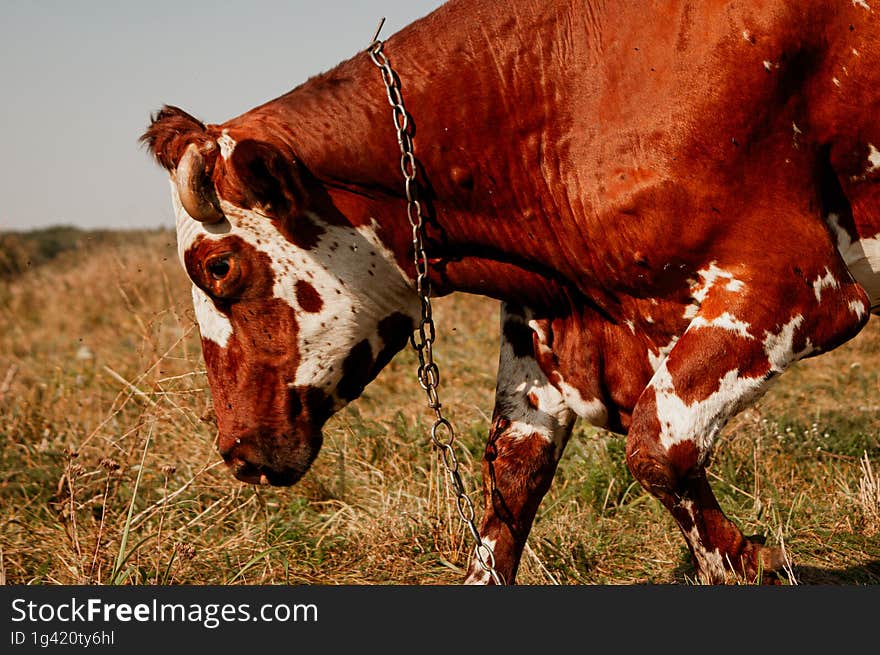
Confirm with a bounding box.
[0,0,442,232]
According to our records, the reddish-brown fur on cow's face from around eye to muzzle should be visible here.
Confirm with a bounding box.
[185,237,332,484]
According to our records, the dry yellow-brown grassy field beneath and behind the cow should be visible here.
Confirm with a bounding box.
[0,231,880,585]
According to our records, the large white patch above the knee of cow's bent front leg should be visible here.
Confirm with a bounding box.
[650,315,812,454]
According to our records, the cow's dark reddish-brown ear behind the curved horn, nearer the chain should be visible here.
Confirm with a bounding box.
[218,139,306,218]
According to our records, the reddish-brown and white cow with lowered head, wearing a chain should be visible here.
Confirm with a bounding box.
[141,0,880,584]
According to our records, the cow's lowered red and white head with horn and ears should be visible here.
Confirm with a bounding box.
[142,107,418,485]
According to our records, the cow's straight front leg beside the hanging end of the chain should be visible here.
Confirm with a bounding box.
[465,304,574,584]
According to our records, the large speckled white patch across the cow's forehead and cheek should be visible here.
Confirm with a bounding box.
[172,183,419,400]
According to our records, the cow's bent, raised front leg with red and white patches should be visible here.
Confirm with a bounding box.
[627,257,868,584]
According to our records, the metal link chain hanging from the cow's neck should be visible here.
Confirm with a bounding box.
[367,19,503,585]
